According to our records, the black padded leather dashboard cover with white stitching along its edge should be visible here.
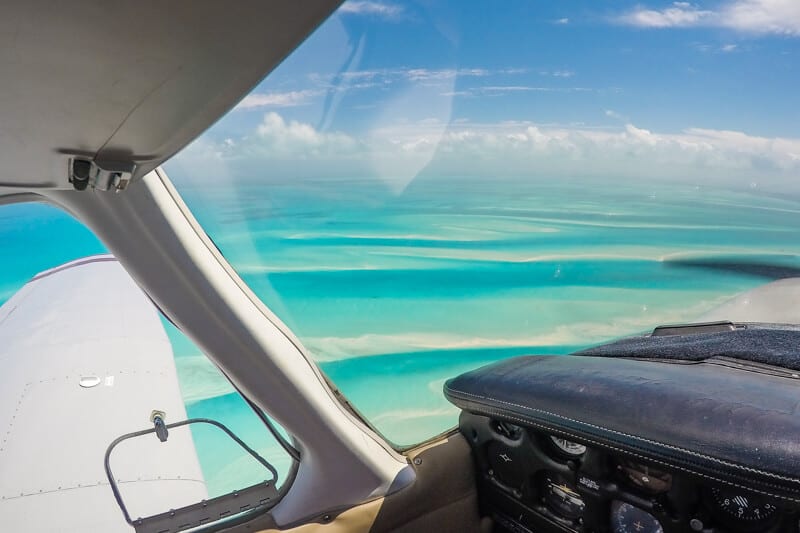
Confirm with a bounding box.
[444,355,800,503]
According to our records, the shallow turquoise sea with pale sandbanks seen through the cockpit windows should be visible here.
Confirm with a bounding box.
[0,176,800,492]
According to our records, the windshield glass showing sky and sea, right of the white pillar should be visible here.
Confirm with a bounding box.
[166,0,800,445]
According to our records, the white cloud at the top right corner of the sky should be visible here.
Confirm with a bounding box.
[618,0,800,36]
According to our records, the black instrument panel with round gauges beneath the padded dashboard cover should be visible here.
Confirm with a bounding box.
[460,412,800,533]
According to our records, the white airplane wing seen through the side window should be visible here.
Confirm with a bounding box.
[0,256,207,532]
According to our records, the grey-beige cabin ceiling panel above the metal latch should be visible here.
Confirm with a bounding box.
[0,0,341,196]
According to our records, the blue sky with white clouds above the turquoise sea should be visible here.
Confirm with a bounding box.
[176,0,800,189]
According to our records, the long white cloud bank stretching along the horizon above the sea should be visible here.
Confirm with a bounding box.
[187,110,800,190]
